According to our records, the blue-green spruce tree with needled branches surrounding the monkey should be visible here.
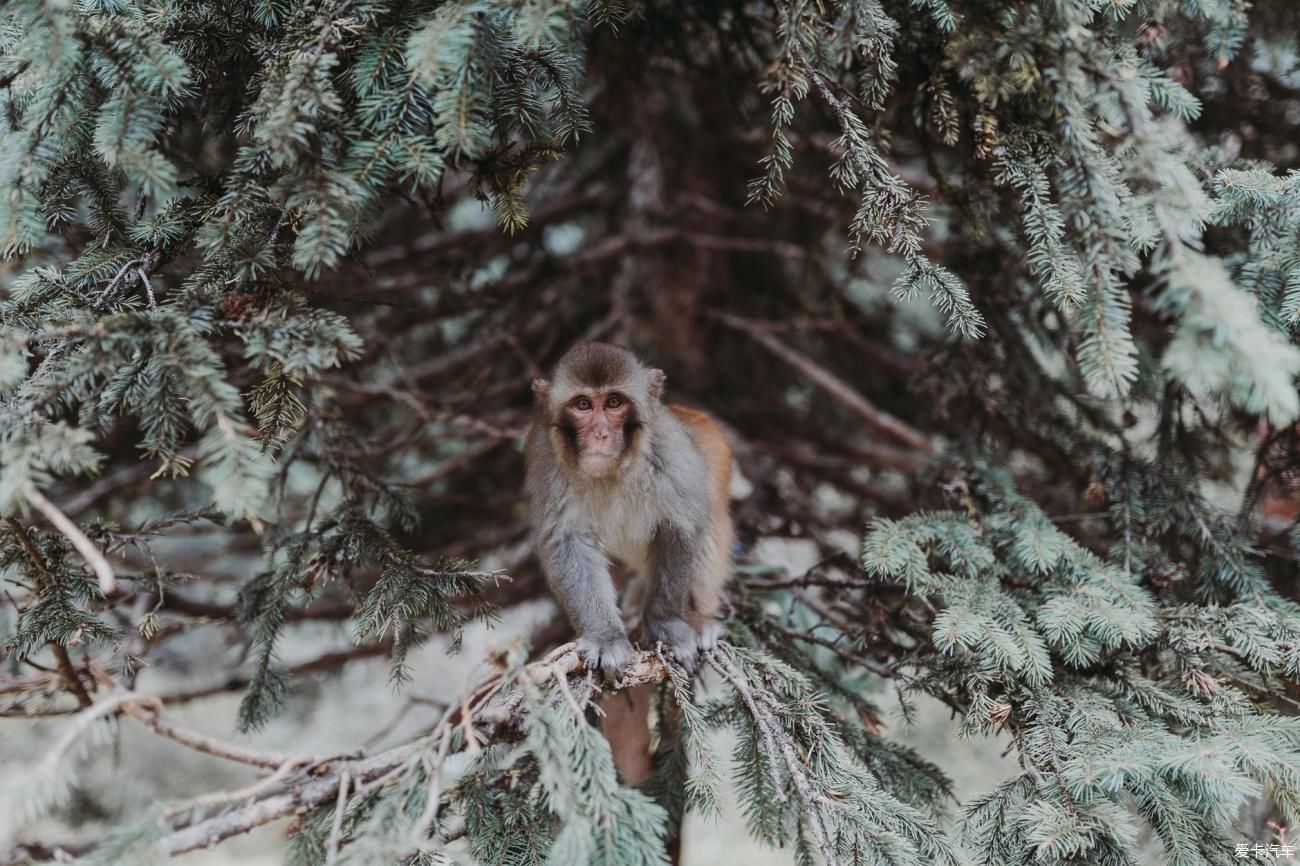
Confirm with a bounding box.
[0,0,1300,866]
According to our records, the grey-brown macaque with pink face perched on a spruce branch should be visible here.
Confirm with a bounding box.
[525,343,732,679]
